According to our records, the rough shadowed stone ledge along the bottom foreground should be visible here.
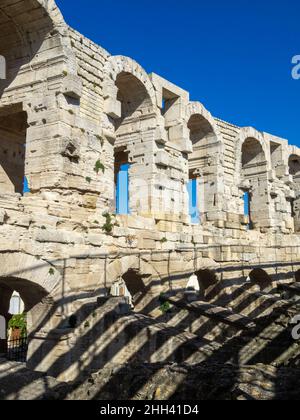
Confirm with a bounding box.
[0,361,300,401]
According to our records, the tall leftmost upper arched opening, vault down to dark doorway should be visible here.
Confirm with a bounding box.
[0,0,64,194]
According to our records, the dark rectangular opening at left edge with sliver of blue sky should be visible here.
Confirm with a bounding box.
[0,104,29,194]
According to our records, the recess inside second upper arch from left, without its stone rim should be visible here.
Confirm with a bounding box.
[114,72,153,215]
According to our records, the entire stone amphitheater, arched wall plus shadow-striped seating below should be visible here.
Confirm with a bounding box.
[0,0,300,399]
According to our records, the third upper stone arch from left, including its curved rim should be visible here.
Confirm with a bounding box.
[185,102,224,222]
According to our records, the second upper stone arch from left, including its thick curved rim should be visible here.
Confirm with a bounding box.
[103,56,159,215]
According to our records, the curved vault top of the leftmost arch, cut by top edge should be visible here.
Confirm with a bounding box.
[0,0,75,104]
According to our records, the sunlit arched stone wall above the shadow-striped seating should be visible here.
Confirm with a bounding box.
[0,0,300,380]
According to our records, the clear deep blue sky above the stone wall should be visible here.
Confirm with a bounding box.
[57,0,300,146]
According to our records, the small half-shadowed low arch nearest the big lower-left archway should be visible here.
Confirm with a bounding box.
[111,270,146,309]
